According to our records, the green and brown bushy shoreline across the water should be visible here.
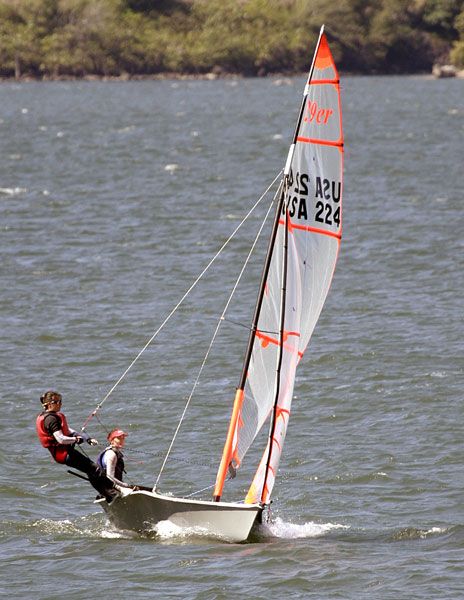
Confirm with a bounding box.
[0,0,464,77]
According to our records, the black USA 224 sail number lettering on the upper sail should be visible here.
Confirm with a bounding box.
[288,172,342,226]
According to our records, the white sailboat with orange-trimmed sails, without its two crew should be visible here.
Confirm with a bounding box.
[98,27,343,542]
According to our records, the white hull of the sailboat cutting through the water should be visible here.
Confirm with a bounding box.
[98,491,263,542]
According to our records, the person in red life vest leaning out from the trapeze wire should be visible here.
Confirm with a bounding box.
[36,390,118,502]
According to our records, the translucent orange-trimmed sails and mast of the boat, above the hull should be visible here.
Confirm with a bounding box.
[214,28,343,504]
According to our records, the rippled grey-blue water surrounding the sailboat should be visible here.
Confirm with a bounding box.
[0,77,464,600]
